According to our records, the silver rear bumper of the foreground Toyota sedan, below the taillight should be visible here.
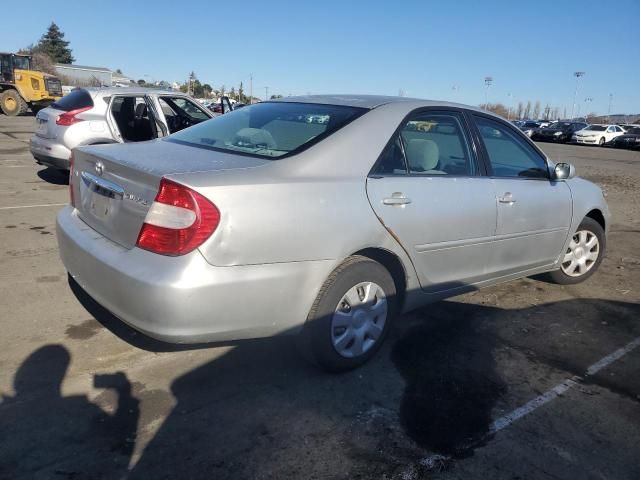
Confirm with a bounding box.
[57,206,335,343]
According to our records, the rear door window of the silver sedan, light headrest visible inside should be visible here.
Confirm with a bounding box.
[400,112,476,176]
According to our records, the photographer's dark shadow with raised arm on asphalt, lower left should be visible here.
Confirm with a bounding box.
[0,345,139,479]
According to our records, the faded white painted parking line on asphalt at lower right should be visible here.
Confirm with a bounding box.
[407,337,640,478]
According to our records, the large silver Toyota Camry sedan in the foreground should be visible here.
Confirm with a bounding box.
[57,95,609,371]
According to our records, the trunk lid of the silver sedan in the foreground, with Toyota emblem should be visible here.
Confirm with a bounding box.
[71,140,270,248]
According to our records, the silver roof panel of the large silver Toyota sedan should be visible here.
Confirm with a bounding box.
[269,94,491,114]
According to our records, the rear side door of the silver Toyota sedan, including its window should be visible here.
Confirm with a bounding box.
[367,110,496,293]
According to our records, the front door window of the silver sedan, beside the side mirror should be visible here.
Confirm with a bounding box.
[474,115,549,178]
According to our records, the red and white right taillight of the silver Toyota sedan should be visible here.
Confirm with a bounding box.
[136,178,220,256]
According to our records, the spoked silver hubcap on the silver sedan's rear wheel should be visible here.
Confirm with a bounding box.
[331,282,387,358]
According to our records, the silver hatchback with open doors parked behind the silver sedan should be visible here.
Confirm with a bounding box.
[29,88,213,170]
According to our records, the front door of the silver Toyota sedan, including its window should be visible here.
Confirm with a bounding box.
[472,114,573,277]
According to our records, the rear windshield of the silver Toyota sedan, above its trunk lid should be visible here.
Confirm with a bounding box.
[167,102,367,158]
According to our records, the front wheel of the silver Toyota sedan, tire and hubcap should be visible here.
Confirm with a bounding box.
[549,217,607,285]
